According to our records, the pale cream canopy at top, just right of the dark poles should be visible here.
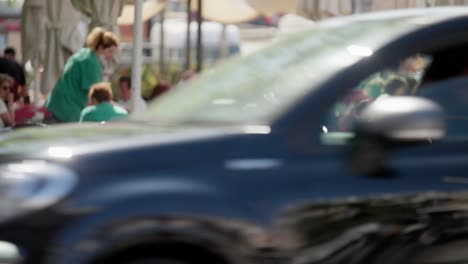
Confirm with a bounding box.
[191,0,258,24]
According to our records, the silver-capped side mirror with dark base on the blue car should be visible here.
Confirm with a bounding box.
[350,96,446,175]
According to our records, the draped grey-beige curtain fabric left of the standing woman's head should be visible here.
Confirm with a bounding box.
[22,0,86,95]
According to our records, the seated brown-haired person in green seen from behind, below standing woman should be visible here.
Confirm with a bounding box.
[80,82,128,122]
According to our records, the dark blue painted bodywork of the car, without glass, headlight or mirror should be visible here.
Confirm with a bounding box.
[0,8,468,264]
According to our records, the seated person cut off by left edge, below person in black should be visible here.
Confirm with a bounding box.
[0,73,15,128]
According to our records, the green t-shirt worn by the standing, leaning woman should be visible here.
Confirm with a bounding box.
[46,48,101,122]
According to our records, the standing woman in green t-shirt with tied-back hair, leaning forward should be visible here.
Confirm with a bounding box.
[46,27,119,122]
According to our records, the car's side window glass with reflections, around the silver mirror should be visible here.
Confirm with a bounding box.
[321,47,468,145]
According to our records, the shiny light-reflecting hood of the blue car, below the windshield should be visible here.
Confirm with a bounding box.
[0,122,252,158]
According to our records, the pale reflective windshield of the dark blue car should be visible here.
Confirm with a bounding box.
[145,18,438,124]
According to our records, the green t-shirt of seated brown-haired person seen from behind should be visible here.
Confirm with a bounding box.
[80,103,128,122]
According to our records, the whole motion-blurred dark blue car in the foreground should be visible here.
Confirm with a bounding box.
[0,7,468,264]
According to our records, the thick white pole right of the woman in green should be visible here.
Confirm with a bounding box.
[132,0,143,113]
